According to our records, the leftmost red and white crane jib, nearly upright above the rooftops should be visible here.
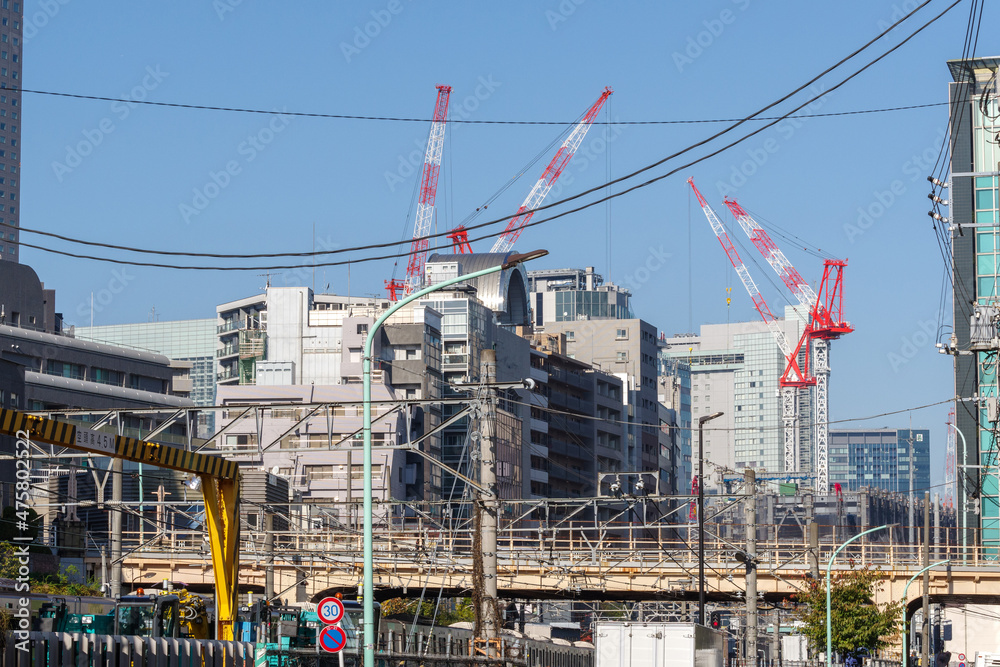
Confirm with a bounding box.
[385,86,451,301]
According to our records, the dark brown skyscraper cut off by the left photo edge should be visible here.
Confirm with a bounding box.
[0,0,24,262]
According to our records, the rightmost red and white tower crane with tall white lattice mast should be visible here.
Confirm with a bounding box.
[725,198,854,494]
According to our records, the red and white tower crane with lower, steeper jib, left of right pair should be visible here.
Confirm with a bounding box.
[688,178,816,471]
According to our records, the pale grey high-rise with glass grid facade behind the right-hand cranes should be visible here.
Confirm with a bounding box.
[660,306,814,486]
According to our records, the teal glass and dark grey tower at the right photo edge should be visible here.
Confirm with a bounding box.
[944,57,1000,555]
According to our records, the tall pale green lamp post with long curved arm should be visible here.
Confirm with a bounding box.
[362,250,549,667]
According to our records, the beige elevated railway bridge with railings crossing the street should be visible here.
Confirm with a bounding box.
[88,499,1000,616]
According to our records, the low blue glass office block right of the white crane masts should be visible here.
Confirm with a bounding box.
[830,428,931,497]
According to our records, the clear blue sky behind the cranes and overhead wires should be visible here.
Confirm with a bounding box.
[15,0,1000,490]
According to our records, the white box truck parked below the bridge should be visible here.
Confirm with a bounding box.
[594,621,726,667]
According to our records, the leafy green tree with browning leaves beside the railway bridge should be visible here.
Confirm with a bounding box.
[795,566,903,654]
